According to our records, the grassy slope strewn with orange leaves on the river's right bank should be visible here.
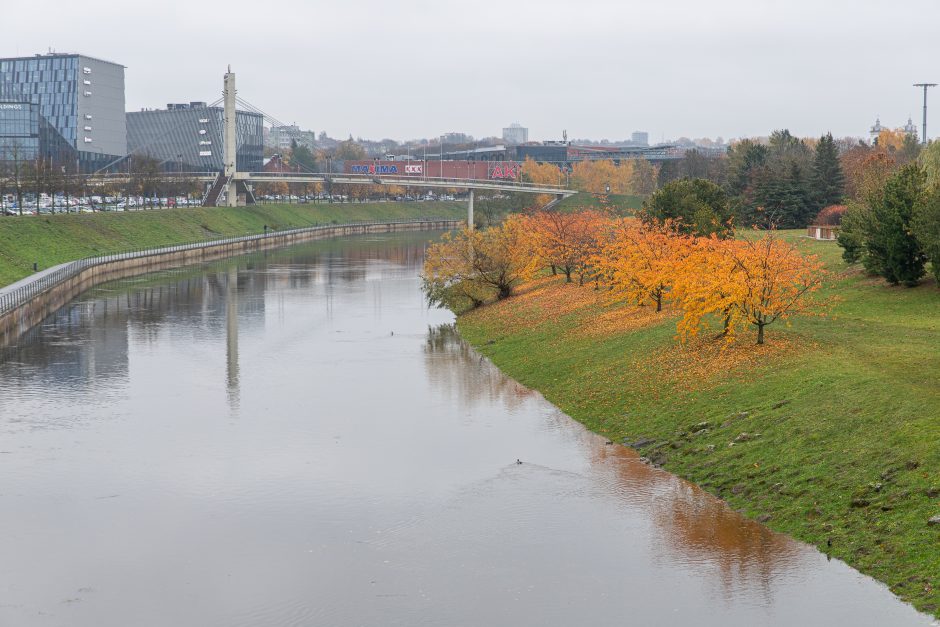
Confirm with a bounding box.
[458,233,940,616]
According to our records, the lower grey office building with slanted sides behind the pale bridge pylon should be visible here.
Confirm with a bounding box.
[127,102,264,172]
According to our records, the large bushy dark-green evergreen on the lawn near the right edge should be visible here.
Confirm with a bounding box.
[863,164,927,286]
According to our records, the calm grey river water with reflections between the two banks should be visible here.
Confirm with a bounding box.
[0,234,934,627]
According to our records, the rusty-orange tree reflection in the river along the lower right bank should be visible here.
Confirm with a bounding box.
[592,442,802,604]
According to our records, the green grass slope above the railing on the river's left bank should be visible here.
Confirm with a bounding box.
[0,202,466,286]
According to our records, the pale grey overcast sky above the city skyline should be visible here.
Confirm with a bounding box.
[7,0,940,141]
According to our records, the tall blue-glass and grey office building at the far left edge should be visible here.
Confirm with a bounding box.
[0,53,127,172]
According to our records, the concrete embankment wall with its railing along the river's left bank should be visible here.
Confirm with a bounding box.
[0,220,463,346]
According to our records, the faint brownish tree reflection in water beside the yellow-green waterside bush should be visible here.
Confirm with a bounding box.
[424,324,533,410]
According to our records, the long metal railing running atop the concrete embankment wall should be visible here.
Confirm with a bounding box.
[0,217,463,317]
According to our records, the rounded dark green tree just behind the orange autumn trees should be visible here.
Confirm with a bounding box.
[639,179,731,236]
